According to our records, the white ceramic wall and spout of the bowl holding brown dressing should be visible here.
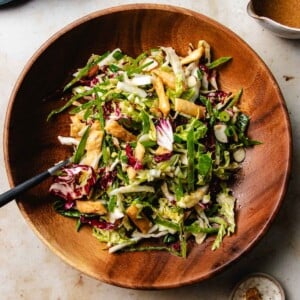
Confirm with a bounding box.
[247,1,300,39]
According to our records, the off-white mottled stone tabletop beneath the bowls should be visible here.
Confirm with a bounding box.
[0,0,300,300]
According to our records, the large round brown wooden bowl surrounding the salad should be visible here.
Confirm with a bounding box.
[4,4,291,289]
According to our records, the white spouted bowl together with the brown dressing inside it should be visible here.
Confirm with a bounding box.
[247,0,300,39]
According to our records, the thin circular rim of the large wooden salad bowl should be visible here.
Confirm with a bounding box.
[3,3,292,289]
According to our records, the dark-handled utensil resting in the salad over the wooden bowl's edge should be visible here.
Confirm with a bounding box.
[0,159,70,207]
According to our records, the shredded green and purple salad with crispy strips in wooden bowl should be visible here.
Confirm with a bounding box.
[48,40,258,257]
